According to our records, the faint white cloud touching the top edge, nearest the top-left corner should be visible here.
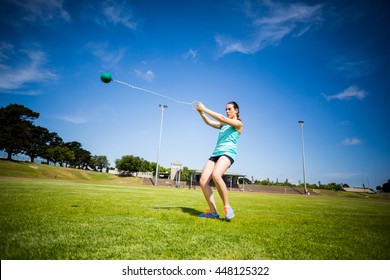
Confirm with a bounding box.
[13,0,71,22]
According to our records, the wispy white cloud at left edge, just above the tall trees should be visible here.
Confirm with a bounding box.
[0,43,57,95]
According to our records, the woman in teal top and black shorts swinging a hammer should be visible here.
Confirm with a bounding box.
[196,101,242,220]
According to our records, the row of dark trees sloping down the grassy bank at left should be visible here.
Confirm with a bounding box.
[0,104,109,172]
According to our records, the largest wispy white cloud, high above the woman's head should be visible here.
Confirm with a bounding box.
[215,0,322,56]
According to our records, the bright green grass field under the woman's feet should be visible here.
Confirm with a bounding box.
[0,162,390,260]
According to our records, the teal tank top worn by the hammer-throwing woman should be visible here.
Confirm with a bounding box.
[212,124,241,160]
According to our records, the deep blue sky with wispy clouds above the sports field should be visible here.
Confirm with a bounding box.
[0,0,390,188]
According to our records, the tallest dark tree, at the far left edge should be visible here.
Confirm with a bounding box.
[0,104,39,160]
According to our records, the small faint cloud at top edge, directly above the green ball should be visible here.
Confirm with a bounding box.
[103,0,137,30]
